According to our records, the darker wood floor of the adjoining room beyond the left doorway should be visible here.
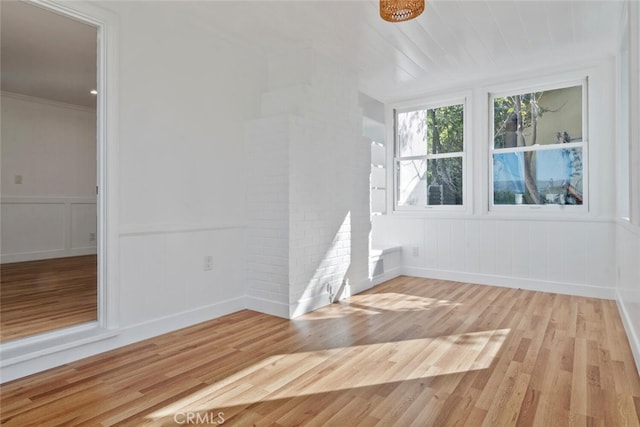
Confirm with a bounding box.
[0,255,97,342]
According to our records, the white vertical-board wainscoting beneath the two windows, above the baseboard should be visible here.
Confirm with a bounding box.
[372,215,615,299]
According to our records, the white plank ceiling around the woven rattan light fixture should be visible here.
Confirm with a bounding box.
[195,0,624,101]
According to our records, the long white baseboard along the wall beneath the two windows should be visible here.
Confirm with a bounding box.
[400,266,616,300]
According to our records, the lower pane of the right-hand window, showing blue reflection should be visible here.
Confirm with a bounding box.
[493,148,583,205]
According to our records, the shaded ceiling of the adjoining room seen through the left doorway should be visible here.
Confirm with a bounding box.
[0,0,97,108]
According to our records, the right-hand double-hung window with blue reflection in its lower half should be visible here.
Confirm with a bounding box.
[490,81,587,209]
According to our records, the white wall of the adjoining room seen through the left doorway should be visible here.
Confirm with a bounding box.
[0,92,96,262]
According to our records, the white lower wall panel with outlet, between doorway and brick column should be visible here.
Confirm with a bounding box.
[118,224,246,333]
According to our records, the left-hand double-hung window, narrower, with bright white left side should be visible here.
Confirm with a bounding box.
[394,100,466,210]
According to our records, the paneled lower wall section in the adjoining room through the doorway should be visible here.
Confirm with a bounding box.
[0,197,97,263]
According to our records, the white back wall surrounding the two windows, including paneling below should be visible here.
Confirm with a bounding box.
[372,58,615,299]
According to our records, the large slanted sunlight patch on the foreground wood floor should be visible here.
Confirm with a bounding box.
[148,329,510,420]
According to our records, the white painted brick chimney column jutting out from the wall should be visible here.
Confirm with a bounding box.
[246,49,370,317]
